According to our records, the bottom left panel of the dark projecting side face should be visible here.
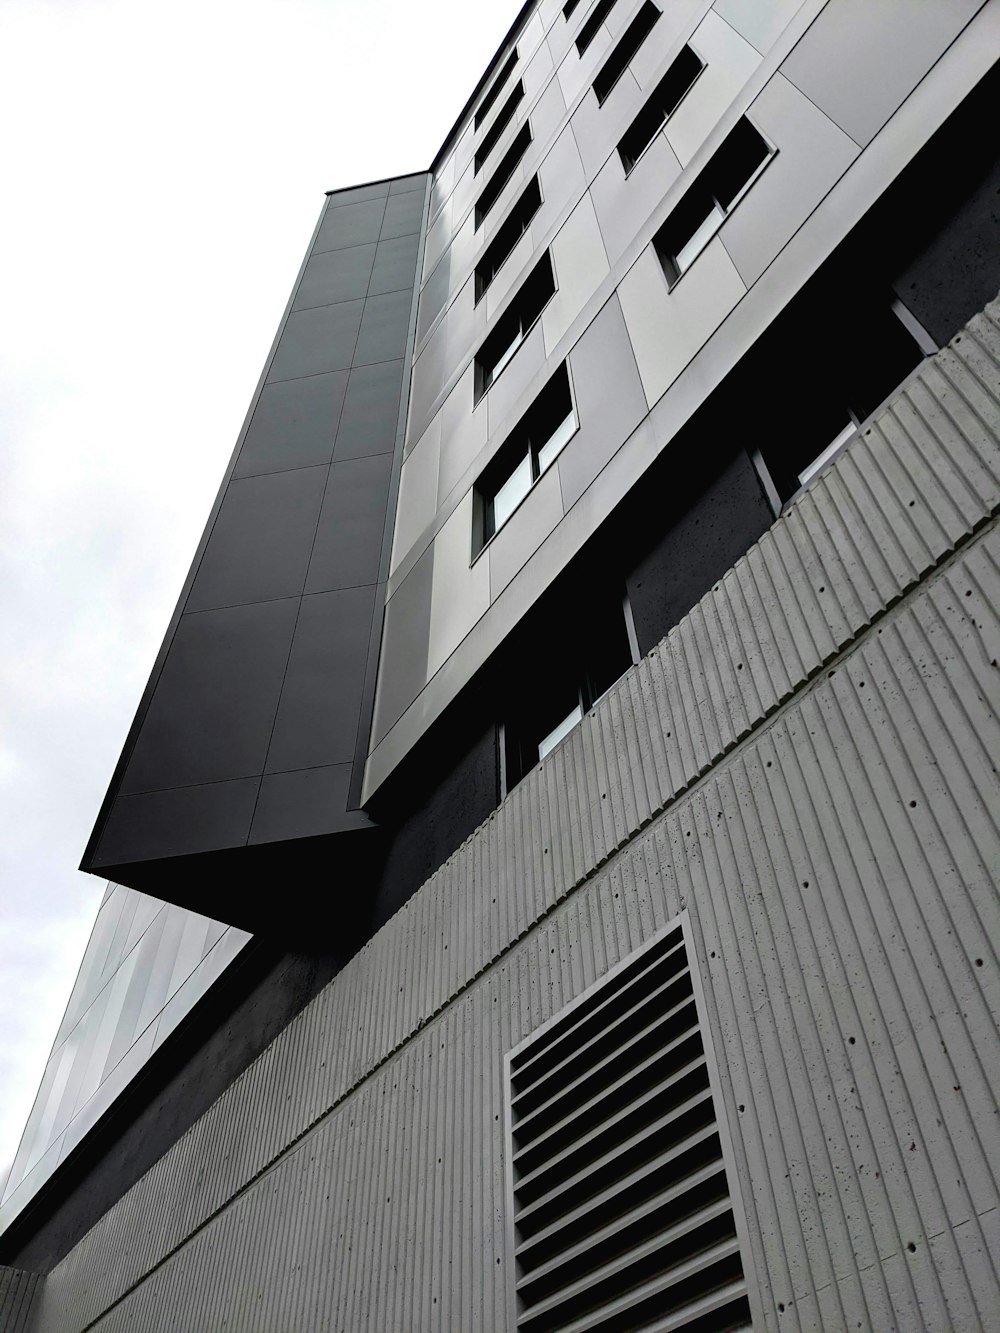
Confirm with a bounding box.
[97,777,260,865]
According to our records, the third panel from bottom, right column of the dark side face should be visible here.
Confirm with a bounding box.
[305,453,392,592]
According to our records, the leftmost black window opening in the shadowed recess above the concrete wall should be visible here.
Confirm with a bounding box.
[500,583,635,796]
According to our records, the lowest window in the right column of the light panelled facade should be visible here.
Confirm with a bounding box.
[653,116,775,285]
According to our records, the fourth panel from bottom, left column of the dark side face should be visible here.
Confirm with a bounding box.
[235,371,348,477]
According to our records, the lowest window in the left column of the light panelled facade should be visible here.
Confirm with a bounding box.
[472,363,579,559]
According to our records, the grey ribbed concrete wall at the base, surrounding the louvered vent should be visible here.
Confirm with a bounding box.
[37,305,1000,1333]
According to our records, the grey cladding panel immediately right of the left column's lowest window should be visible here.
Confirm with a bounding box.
[559,296,647,509]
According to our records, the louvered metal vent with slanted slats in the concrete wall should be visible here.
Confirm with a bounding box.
[511,925,751,1333]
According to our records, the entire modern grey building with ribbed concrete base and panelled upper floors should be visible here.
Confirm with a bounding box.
[0,0,1000,1333]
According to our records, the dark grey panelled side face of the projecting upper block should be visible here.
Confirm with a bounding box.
[84,173,431,920]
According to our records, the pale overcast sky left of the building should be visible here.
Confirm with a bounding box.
[0,0,520,1185]
